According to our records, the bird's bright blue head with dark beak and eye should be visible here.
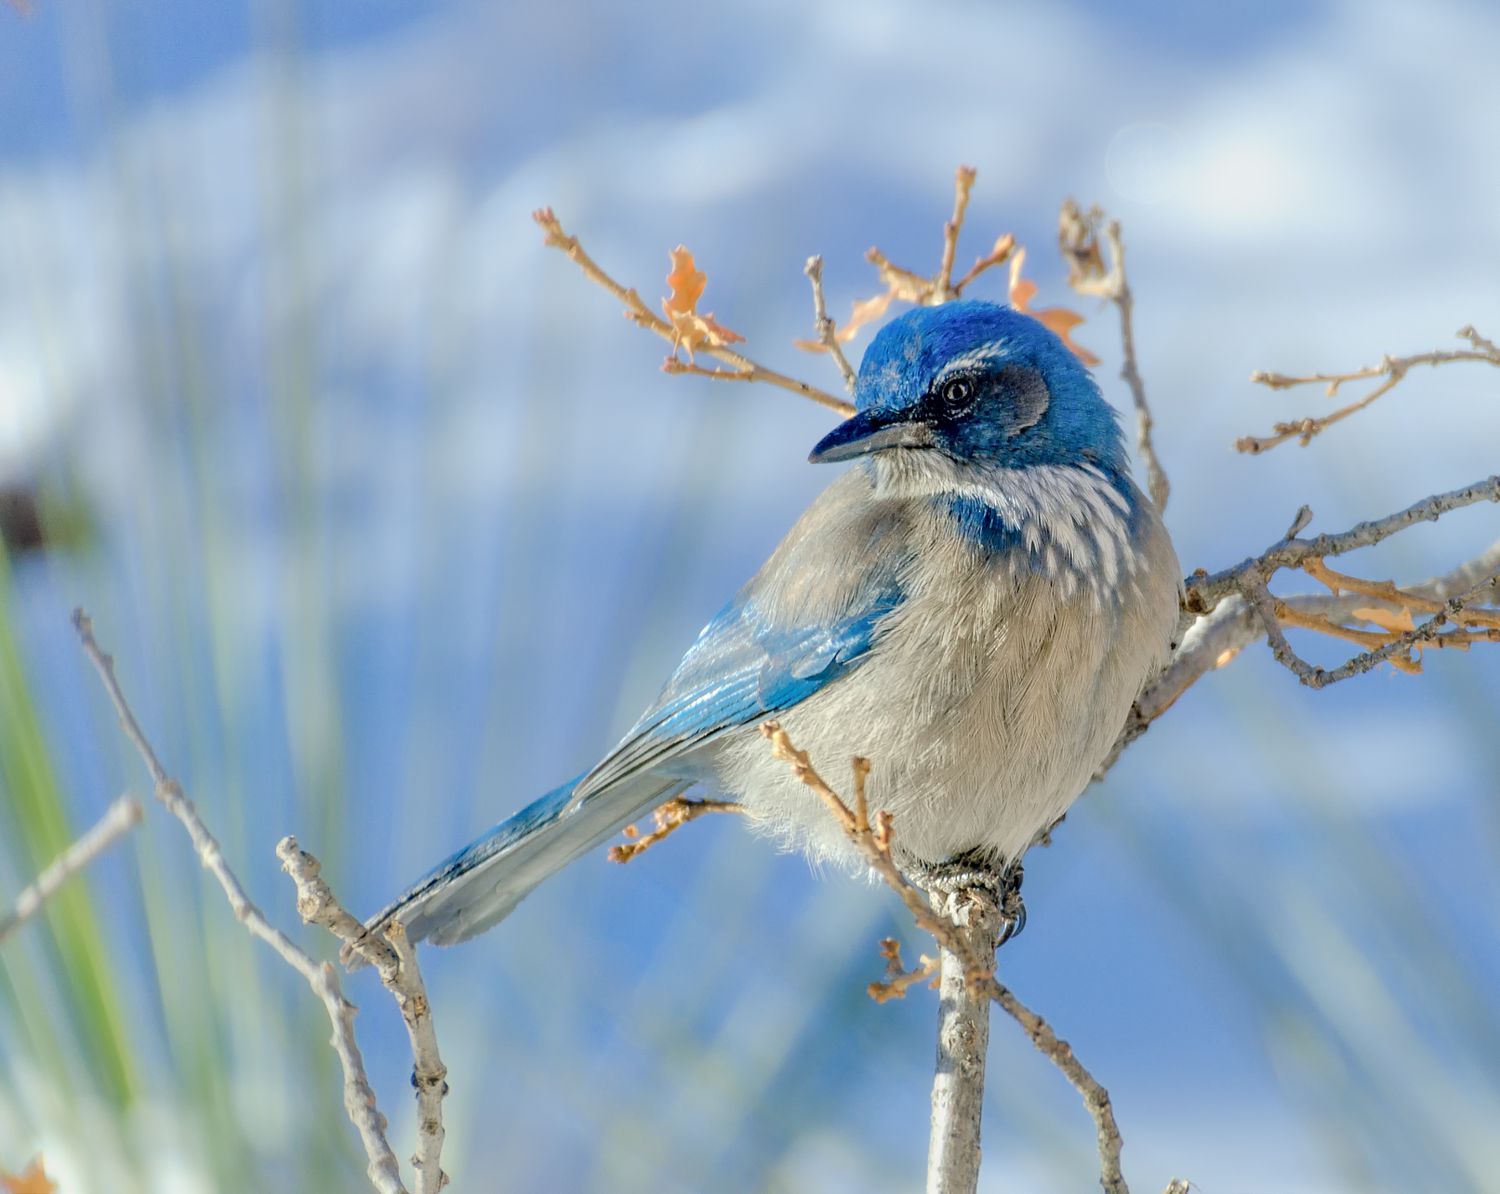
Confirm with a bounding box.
[809,300,1127,474]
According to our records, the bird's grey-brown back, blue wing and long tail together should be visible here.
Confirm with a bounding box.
[371,470,909,945]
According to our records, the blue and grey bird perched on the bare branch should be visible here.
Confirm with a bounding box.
[372,300,1181,945]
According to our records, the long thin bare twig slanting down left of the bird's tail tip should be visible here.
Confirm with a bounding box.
[74,609,407,1194]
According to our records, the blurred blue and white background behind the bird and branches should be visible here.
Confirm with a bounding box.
[0,0,1500,1194]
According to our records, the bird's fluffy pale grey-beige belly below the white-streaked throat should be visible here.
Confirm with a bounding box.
[714,549,1176,861]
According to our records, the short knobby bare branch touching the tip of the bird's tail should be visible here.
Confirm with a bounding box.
[276,837,449,1194]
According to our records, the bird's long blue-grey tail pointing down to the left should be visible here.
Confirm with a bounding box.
[368,773,689,945]
